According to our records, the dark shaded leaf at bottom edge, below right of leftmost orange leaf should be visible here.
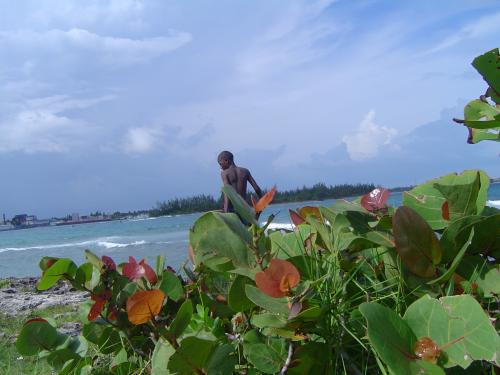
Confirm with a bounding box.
[168,336,215,375]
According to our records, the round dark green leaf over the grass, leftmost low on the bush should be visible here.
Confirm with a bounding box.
[16,320,57,355]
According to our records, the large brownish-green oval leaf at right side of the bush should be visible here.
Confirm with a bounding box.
[392,206,442,278]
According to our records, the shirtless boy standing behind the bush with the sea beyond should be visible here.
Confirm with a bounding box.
[217,151,262,212]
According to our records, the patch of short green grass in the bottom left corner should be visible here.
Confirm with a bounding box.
[0,305,79,375]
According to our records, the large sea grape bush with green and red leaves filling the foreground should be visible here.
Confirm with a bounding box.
[17,170,500,375]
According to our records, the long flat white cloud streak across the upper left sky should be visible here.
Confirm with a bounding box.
[0,28,192,65]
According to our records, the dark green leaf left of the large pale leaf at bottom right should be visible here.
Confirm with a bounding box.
[359,302,417,374]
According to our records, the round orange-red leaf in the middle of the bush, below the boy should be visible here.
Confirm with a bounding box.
[255,259,300,298]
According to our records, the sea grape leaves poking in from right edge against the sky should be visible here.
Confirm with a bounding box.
[454,48,500,143]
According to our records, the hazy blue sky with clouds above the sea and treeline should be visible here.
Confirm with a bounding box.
[0,0,500,217]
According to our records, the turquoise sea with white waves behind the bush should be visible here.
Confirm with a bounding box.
[0,184,500,278]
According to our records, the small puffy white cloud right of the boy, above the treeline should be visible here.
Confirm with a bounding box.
[342,110,397,161]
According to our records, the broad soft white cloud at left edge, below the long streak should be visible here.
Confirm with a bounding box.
[0,95,113,154]
